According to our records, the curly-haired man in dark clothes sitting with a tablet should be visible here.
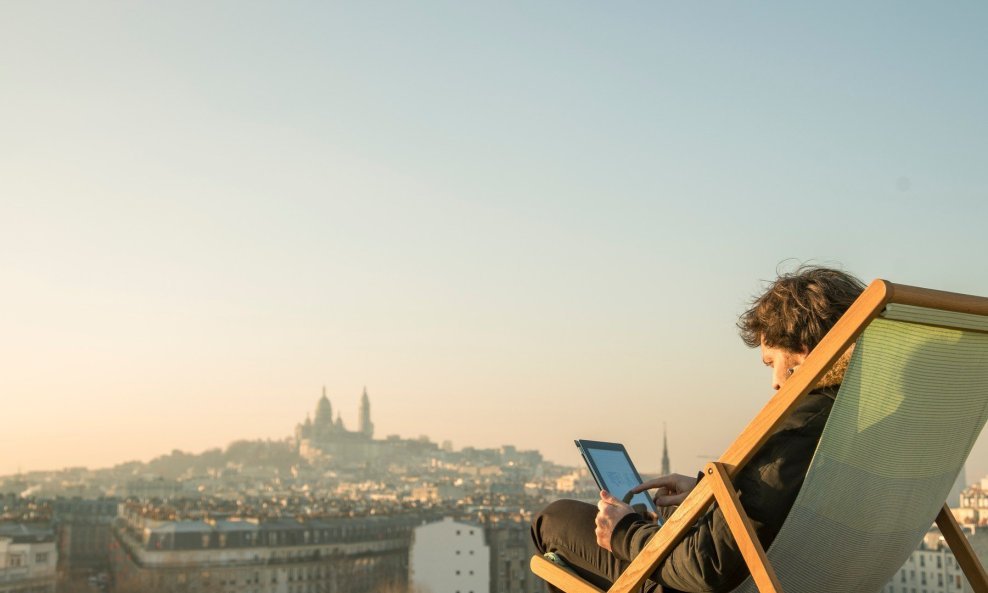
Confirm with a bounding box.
[532,266,864,592]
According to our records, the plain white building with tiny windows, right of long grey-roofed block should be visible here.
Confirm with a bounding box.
[409,517,491,593]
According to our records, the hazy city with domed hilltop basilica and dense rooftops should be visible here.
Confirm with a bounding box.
[0,389,988,593]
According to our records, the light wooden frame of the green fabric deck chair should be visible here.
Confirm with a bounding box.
[531,279,988,593]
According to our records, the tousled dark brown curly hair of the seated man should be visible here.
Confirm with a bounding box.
[738,265,865,352]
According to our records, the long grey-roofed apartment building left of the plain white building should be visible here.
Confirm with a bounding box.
[110,505,418,593]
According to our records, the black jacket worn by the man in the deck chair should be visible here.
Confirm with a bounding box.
[611,386,837,592]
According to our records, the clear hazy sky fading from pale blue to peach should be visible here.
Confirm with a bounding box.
[0,1,988,480]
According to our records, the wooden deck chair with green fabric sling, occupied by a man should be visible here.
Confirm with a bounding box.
[531,280,988,593]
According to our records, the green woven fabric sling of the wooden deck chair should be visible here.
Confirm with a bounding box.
[735,304,988,593]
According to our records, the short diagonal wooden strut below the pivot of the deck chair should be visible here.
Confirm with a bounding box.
[704,463,782,593]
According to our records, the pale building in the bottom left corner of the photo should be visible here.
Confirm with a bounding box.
[0,523,58,593]
